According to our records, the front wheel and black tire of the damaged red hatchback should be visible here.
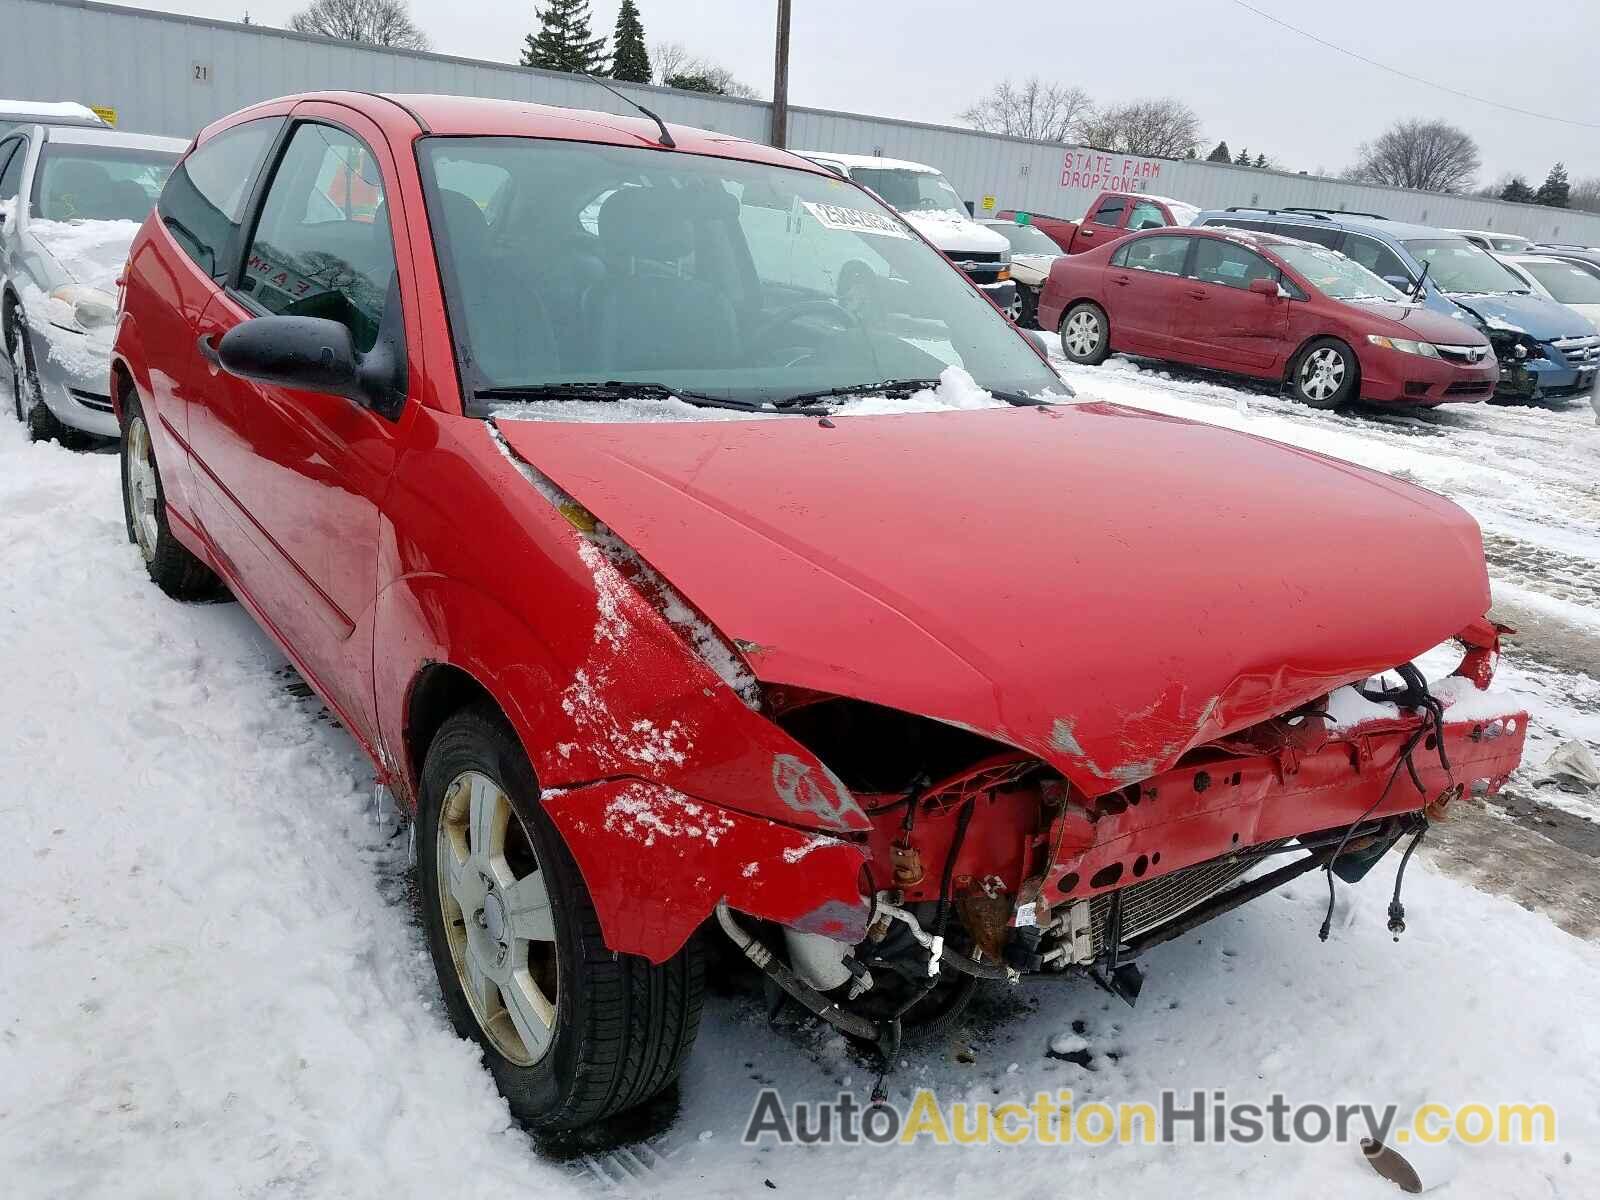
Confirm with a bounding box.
[418,709,704,1133]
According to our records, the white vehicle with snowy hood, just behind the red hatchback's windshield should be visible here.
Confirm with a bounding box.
[797,150,1021,320]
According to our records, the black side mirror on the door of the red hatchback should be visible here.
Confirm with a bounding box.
[216,317,405,419]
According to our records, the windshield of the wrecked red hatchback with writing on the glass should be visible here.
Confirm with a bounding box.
[421,138,1066,414]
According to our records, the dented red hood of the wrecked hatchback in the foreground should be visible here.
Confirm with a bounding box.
[501,405,1490,794]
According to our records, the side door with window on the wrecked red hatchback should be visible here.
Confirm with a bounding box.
[190,104,416,744]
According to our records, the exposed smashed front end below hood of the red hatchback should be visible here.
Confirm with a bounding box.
[720,621,1526,1068]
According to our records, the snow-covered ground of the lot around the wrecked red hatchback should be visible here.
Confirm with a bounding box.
[0,362,1600,1200]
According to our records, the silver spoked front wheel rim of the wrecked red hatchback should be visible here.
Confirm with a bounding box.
[435,771,557,1067]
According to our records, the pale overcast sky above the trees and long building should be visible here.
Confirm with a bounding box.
[106,0,1600,184]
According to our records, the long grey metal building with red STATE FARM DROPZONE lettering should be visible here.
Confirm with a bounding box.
[0,0,1600,245]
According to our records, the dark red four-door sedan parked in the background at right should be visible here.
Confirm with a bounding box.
[1038,229,1499,408]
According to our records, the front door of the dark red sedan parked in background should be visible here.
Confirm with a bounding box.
[1173,237,1290,374]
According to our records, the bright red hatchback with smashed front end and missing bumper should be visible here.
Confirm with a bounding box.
[112,94,1523,1130]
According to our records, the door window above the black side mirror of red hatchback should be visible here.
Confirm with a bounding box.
[238,123,396,354]
